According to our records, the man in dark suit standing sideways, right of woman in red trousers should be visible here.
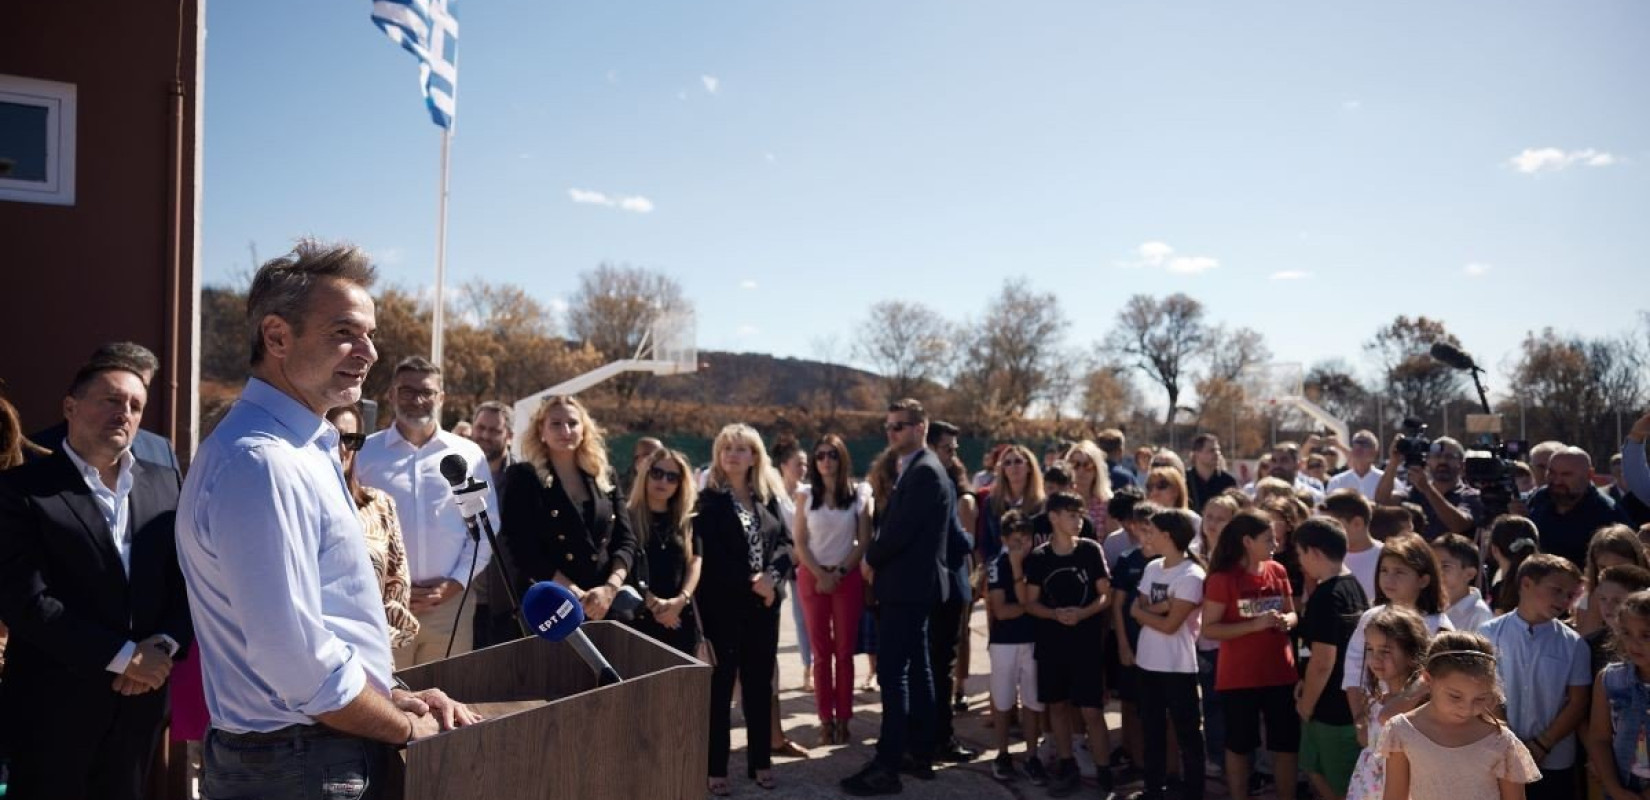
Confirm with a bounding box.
[842,399,957,797]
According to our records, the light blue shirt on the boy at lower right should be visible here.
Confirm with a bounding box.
[1478,610,1592,770]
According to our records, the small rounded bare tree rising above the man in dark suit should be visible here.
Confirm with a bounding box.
[855,300,952,401]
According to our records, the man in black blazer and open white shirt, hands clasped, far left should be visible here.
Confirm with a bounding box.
[0,361,191,800]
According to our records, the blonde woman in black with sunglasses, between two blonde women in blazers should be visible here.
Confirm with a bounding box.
[625,449,703,655]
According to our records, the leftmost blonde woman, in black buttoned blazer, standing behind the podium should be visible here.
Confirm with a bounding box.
[498,394,637,620]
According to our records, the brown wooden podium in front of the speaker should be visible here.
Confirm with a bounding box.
[391,622,711,800]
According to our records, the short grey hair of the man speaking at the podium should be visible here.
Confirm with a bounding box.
[246,239,378,366]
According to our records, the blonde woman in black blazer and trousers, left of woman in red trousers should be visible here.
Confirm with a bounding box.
[693,424,794,797]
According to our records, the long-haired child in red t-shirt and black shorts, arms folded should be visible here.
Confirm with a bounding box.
[1203,511,1300,800]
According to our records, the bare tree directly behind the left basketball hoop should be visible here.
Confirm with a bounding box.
[568,262,688,407]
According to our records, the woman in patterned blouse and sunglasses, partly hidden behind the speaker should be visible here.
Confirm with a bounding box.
[327,406,417,650]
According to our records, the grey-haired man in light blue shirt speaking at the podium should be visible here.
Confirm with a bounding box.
[178,241,479,800]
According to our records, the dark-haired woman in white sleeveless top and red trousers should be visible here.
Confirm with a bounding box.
[794,434,871,746]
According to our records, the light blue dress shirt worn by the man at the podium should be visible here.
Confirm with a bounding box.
[178,378,393,732]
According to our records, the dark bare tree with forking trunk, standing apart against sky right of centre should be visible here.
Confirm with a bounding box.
[1106,292,1209,426]
